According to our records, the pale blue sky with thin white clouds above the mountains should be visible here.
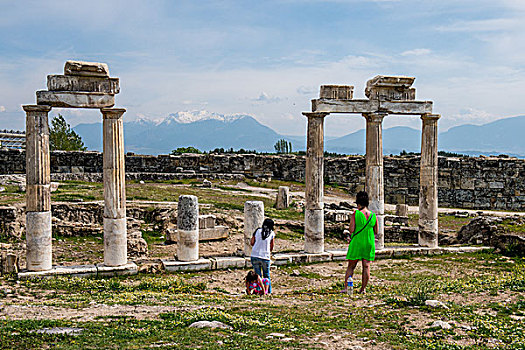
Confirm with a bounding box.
[0,0,525,135]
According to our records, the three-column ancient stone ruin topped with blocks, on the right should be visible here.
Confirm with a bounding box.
[303,75,440,253]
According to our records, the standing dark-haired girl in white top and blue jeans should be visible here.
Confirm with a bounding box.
[250,219,275,293]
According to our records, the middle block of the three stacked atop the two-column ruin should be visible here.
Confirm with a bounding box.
[47,75,120,94]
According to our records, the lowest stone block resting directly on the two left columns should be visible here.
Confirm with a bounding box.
[36,90,115,109]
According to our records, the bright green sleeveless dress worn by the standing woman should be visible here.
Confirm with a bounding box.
[346,210,376,261]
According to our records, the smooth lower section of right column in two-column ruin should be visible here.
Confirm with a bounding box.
[104,218,128,266]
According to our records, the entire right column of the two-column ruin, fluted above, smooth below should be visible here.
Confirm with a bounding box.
[100,108,128,266]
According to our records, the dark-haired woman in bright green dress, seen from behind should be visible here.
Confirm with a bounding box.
[343,191,378,293]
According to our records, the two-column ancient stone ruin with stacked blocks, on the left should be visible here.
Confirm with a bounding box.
[23,61,131,271]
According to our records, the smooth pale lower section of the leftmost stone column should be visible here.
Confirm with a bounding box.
[26,211,53,271]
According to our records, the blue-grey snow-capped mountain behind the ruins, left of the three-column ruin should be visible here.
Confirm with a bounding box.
[74,111,290,154]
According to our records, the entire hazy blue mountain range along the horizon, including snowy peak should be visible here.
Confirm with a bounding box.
[73,111,525,157]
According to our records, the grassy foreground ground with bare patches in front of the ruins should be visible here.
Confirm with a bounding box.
[0,252,525,349]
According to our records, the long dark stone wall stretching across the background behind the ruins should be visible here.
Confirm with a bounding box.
[0,150,525,211]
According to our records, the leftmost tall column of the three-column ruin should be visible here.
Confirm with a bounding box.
[303,113,327,253]
